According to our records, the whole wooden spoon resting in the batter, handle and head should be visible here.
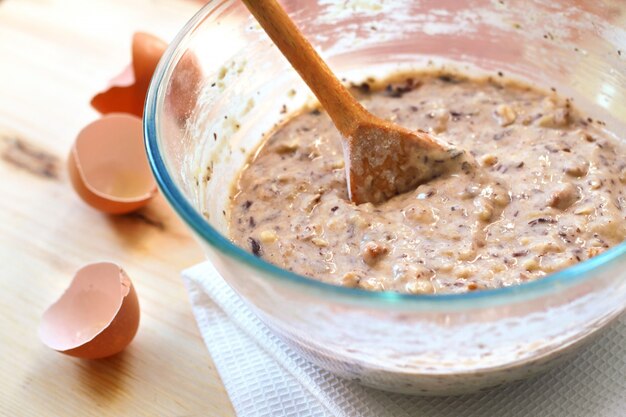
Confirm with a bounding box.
[242,0,465,204]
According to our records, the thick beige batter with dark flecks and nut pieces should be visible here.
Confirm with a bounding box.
[230,74,626,293]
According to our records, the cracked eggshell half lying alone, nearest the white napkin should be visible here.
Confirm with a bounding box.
[39,262,139,359]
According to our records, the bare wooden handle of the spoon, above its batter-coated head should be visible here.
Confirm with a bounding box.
[242,0,369,137]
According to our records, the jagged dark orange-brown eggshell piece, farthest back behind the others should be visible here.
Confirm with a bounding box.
[91,32,167,117]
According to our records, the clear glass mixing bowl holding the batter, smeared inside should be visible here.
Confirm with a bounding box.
[145,0,626,394]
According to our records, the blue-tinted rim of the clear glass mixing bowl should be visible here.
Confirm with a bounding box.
[143,0,626,308]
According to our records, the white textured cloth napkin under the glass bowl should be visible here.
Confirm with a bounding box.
[183,262,626,417]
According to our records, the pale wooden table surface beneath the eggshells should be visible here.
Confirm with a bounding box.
[0,0,234,416]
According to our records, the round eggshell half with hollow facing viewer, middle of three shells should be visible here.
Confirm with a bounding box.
[68,114,156,214]
